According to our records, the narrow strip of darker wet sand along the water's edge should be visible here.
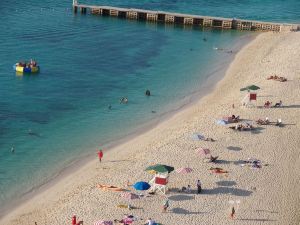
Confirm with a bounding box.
[0,33,257,222]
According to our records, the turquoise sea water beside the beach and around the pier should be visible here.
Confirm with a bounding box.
[0,0,300,214]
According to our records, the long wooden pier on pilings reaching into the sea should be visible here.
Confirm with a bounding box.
[73,0,299,32]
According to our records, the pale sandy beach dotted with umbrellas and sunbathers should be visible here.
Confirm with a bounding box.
[0,32,300,225]
